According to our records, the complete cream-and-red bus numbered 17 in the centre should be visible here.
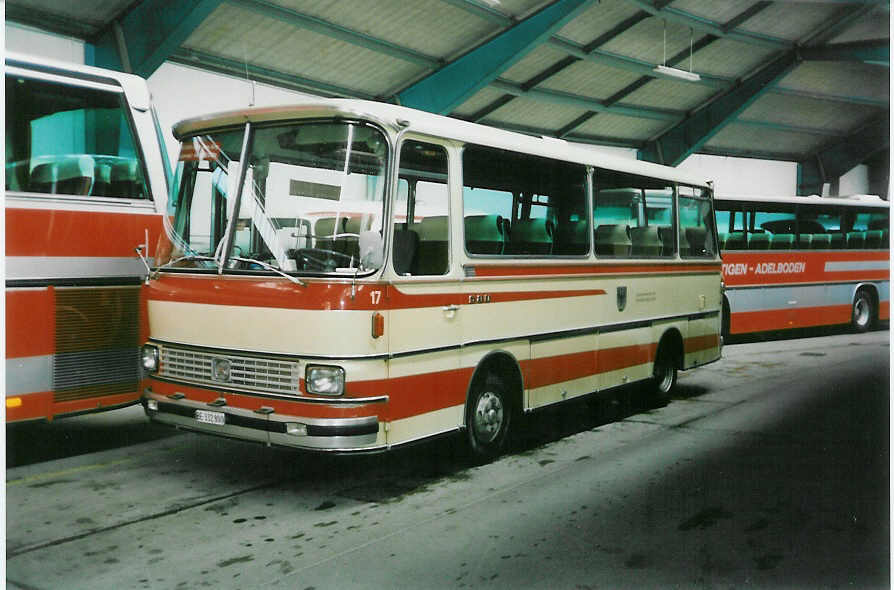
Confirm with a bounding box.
[143,100,722,459]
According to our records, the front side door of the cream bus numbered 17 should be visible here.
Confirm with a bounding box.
[385,139,468,444]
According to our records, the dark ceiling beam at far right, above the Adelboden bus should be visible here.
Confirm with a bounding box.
[798,113,891,195]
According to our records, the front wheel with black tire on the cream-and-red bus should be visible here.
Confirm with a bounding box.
[466,375,512,464]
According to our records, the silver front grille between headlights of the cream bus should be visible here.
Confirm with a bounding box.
[159,346,301,395]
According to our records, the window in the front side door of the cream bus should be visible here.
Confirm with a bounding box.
[391,140,450,276]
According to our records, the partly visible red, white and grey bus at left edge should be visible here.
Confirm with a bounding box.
[5,54,170,422]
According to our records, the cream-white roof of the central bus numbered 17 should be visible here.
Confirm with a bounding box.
[174,99,707,186]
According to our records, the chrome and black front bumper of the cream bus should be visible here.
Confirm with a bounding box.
[141,387,386,452]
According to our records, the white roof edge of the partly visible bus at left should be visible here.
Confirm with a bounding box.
[4,52,151,111]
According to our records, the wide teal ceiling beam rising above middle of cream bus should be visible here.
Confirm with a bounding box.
[397,0,595,114]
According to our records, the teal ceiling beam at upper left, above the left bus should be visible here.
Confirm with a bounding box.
[84,0,222,78]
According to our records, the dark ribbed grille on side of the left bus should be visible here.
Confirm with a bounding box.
[53,286,140,402]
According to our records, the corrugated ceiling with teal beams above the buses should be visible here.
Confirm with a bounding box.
[6,0,890,180]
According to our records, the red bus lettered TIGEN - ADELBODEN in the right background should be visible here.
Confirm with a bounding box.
[715,195,890,334]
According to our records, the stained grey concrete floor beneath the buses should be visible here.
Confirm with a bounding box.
[6,331,890,589]
